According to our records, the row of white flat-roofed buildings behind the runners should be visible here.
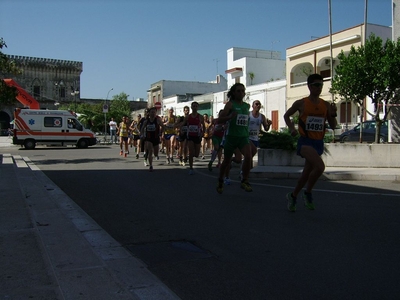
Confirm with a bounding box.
[148,47,286,130]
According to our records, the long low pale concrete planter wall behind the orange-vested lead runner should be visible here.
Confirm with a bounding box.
[258,143,400,168]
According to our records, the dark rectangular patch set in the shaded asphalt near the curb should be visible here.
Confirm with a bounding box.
[126,241,214,266]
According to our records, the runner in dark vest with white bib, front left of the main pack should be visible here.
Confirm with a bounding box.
[141,107,164,172]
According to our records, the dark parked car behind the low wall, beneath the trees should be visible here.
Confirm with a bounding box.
[339,121,388,143]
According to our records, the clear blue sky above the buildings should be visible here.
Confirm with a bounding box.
[0,0,392,99]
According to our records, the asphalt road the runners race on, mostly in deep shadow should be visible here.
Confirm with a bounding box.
[5,145,400,300]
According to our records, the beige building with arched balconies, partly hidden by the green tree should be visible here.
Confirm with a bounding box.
[286,24,392,124]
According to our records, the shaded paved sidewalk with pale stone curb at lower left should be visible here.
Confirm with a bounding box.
[0,155,179,300]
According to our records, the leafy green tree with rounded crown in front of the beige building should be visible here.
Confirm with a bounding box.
[331,34,400,143]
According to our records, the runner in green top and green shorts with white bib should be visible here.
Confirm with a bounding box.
[217,83,253,194]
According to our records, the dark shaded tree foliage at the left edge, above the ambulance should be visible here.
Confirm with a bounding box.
[0,38,21,106]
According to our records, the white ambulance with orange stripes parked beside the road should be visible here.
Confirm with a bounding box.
[13,108,96,149]
